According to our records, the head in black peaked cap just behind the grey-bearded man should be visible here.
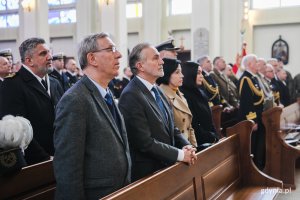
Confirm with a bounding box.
[155,39,180,59]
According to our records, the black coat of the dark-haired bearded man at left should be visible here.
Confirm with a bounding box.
[0,67,54,164]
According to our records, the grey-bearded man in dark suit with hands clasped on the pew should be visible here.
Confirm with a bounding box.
[119,43,196,181]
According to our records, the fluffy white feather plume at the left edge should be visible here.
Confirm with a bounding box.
[0,115,33,150]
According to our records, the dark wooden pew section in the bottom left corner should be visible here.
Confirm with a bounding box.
[0,160,55,200]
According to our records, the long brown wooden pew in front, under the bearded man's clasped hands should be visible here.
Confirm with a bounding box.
[103,121,282,200]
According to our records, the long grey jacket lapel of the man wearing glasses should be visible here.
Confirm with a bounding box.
[81,75,124,144]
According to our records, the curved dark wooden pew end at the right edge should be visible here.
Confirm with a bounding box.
[262,103,300,189]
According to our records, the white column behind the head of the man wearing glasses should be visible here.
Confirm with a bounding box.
[95,0,128,75]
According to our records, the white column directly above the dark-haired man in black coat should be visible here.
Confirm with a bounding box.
[17,0,49,44]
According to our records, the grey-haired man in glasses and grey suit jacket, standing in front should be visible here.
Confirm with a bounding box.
[54,33,131,199]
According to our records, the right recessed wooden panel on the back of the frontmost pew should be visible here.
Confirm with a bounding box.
[202,155,240,199]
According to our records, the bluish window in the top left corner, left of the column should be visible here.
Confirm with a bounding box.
[0,0,19,28]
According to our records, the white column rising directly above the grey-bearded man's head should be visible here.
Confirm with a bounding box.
[142,0,162,46]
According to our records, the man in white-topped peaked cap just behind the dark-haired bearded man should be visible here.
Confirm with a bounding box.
[49,53,69,92]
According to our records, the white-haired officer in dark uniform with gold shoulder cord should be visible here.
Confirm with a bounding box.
[239,54,265,169]
